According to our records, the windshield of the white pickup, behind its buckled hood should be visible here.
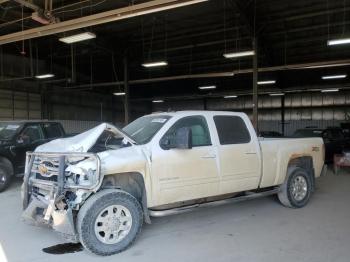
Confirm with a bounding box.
[123,115,170,144]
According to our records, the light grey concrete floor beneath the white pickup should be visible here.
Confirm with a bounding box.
[0,172,350,262]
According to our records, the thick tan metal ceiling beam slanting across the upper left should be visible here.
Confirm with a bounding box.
[0,0,207,45]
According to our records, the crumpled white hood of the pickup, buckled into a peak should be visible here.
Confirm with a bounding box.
[35,123,135,153]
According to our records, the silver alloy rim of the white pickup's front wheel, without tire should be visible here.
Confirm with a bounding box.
[95,205,132,245]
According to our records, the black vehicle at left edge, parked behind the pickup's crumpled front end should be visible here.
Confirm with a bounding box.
[0,121,66,192]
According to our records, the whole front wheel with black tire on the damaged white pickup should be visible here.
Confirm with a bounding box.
[77,190,143,256]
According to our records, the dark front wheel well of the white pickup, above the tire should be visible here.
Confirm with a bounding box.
[101,173,151,224]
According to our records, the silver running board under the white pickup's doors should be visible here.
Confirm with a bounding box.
[149,188,280,217]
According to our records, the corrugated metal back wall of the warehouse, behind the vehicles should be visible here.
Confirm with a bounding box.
[0,90,350,135]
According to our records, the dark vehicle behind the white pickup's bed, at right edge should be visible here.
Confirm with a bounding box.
[293,127,350,163]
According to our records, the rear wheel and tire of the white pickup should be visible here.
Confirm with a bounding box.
[278,167,312,208]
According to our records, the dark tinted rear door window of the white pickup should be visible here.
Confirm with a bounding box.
[214,115,251,145]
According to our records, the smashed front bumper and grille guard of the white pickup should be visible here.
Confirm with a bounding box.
[22,153,100,242]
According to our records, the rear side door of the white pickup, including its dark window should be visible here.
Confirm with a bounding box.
[214,115,261,194]
